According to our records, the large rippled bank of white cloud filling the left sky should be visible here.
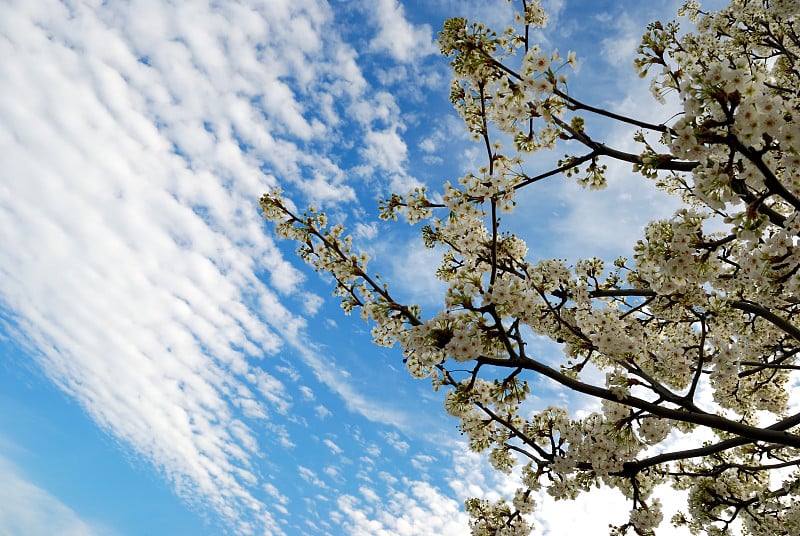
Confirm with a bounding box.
[0,0,444,534]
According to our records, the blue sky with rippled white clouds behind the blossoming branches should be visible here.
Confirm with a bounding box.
[0,0,724,536]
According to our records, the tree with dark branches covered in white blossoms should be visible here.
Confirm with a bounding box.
[261,0,800,536]
